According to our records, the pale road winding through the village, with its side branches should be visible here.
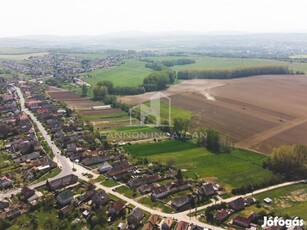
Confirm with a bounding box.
[0,88,306,229]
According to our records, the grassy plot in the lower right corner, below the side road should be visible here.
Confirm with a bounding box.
[255,184,307,220]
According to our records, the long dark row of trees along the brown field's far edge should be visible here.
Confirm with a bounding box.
[177,65,290,80]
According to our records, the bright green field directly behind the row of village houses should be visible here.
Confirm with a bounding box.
[125,140,274,188]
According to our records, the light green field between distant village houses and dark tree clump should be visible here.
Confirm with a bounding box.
[83,60,153,86]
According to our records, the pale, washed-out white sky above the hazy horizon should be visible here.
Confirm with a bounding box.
[0,0,307,37]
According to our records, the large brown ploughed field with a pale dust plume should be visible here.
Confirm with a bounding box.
[119,75,307,153]
